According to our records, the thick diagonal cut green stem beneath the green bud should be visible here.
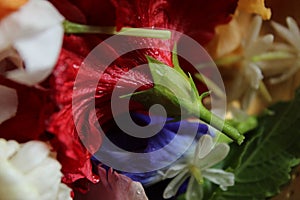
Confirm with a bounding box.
[199,92,245,144]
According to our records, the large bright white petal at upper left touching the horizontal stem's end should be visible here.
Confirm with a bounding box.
[7,25,63,85]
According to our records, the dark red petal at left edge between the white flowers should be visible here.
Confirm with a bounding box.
[0,77,54,142]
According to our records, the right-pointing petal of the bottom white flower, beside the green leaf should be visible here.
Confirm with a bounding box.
[202,169,234,190]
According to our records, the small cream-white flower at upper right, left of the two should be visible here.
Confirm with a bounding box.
[228,16,274,110]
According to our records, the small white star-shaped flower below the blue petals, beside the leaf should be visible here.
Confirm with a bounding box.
[163,135,234,200]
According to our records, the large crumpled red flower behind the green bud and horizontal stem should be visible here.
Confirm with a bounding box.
[48,0,237,189]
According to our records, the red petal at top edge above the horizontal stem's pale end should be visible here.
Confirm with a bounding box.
[112,0,237,45]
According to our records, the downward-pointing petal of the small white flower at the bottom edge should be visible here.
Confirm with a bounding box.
[185,177,203,200]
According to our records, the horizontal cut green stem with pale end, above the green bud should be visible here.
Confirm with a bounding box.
[63,20,171,39]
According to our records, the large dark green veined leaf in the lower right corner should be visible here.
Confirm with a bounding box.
[211,90,300,200]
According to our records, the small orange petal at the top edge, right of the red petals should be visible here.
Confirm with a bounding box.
[238,0,271,20]
